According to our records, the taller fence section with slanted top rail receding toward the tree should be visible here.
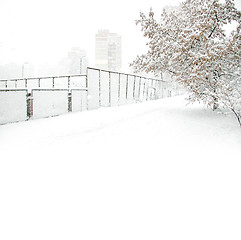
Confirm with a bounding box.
[87,68,168,109]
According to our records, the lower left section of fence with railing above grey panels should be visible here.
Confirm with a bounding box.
[0,75,88,124]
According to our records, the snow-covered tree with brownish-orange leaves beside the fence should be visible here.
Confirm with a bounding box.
[131,0,241,126]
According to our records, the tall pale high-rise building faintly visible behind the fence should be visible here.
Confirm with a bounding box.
[95,30,121,71]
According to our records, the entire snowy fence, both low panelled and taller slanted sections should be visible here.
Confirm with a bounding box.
[0,68,171,124]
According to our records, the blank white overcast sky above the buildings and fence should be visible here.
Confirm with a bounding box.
[0,0,241,71]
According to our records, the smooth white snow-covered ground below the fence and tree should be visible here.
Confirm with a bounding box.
[0,97,241,240]
